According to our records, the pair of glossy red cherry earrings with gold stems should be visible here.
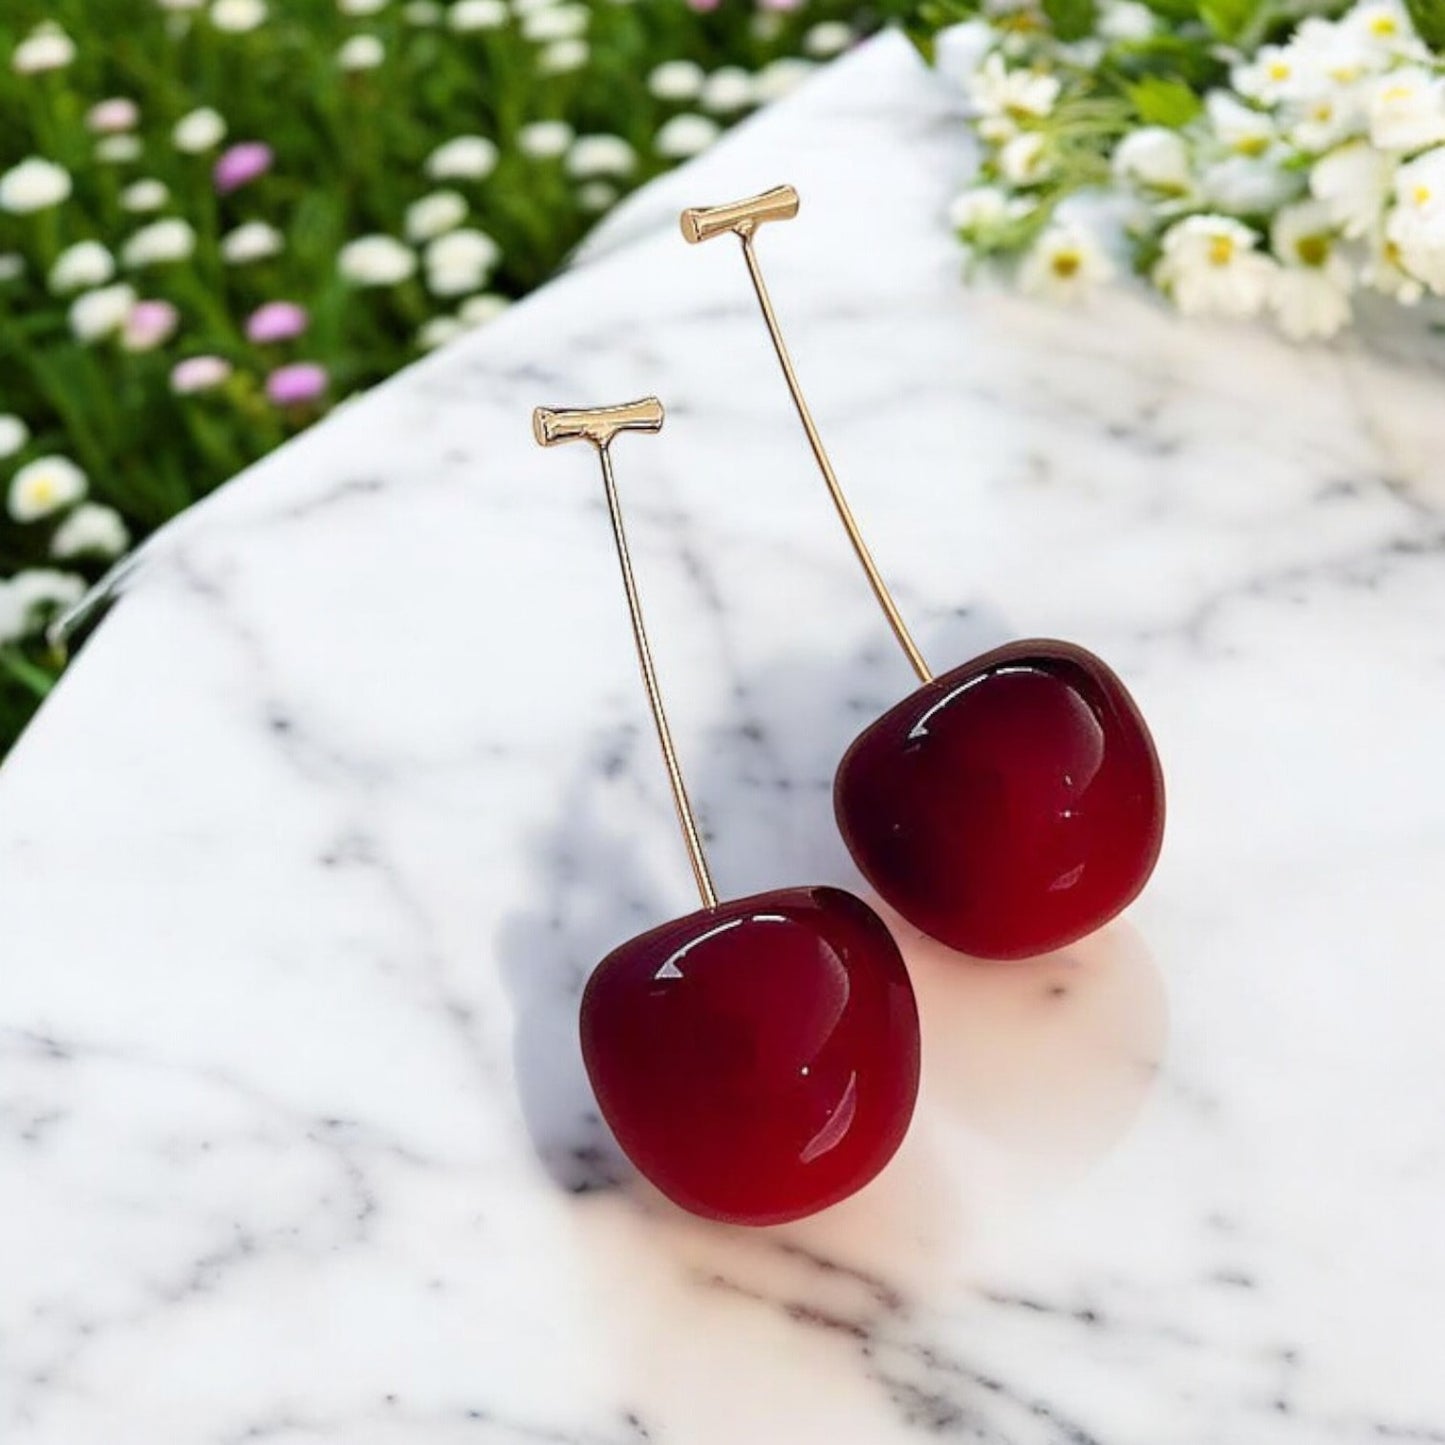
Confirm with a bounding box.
[533,186,1163,1225]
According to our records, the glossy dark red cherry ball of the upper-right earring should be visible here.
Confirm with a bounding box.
[834,642,1165,958]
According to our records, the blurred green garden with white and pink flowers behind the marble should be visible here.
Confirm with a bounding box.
[0,0,886,756]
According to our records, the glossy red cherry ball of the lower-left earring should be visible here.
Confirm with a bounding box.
[582,887,919,1224]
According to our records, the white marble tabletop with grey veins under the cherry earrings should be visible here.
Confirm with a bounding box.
[0,40,1445,1445]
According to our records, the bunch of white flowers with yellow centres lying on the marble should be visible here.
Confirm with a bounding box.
[915,0,1445,340]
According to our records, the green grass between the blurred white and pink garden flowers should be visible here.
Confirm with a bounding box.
[0,0,879,756]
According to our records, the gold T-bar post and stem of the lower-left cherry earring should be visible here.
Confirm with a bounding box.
[532,396,718,907]
